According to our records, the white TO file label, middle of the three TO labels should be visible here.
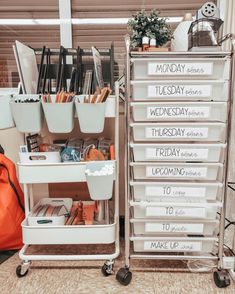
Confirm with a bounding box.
[146,206,206,218]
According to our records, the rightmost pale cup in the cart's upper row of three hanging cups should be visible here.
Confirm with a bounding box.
[75,95,106,133]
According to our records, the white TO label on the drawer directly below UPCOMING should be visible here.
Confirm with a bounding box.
[145,185,206,198]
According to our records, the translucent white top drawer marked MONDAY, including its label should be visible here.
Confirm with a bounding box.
[131,57,231,80]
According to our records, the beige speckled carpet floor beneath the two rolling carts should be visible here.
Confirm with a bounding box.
[0,246,235,294]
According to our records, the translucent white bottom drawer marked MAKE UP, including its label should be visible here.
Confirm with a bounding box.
[130,237,218,253]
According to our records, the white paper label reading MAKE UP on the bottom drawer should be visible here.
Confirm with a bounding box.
[144,240,202,251]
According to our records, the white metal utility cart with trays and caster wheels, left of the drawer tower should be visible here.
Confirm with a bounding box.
[16,83,120,277]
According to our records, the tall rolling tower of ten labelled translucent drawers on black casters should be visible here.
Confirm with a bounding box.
[116,38,234,287]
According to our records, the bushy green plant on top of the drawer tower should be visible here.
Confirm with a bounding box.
[128,9,172,48]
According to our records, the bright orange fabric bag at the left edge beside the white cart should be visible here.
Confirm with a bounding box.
[0,154,25,250]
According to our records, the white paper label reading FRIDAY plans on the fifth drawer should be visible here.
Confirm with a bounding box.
[145,147,208,160]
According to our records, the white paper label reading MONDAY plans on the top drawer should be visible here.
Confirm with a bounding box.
[148,62,213,76]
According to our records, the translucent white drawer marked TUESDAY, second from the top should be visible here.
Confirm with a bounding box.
[131,80,229,101]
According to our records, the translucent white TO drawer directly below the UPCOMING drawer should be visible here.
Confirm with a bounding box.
[130,182,223,202]
